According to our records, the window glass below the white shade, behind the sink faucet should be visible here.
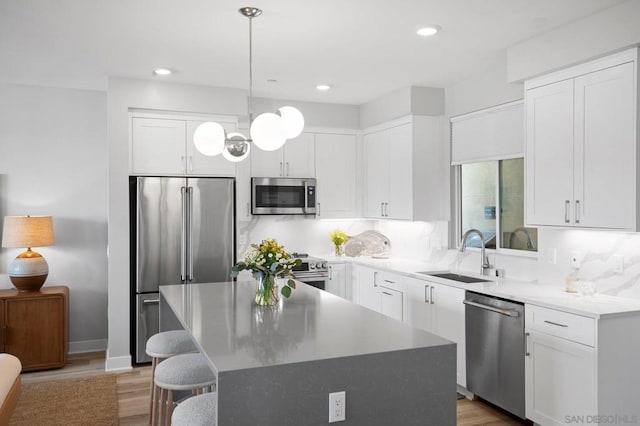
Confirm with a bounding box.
[459,158,538,252]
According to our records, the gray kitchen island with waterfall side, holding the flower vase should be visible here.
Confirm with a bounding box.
[160,281,456,426]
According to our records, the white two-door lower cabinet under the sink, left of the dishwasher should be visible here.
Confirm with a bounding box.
[405,277,467,387]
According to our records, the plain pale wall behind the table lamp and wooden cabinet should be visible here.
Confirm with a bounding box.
[0,84,107,352]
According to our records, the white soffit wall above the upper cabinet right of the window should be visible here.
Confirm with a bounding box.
[507,0,640,81]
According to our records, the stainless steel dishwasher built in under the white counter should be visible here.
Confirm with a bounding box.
[464,291,525,419]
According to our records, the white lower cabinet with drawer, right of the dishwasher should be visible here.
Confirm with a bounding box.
[525,304,640,426]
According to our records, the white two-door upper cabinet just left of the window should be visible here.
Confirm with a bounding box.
[364,116,445,220]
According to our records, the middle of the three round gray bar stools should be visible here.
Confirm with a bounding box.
[154,354,216,425]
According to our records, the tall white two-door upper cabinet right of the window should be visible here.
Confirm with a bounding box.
[525,49,638,230]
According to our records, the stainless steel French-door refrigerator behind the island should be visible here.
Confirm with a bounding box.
[129,176,235,363]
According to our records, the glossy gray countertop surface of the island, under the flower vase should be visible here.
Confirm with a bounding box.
[161,281,450,372]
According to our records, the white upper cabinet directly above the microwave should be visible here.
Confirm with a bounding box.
[249,133,315,178]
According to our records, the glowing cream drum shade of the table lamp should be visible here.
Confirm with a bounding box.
[2,216,55,248]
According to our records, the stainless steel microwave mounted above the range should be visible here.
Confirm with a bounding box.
[251,178,316,215]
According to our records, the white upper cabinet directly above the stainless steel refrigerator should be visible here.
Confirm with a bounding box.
[130,114,236,176]
